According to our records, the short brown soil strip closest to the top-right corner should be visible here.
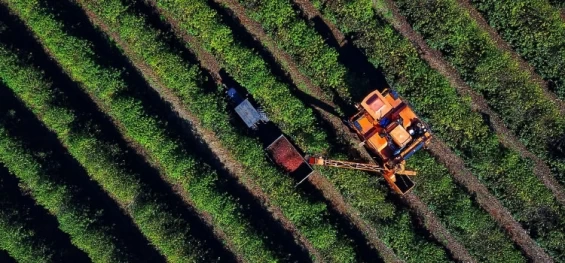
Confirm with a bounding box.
[457,0,565,115]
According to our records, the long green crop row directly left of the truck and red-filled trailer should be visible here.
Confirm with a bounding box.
[76,0,362,262]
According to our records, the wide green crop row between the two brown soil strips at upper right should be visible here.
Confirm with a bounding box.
[390,0,565,192]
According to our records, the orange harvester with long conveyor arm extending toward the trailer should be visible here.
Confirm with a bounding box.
[308,89,432,194]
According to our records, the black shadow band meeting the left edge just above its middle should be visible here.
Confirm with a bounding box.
[0,85,156,260]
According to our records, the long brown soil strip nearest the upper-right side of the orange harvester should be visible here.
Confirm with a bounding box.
[376,0,565,209]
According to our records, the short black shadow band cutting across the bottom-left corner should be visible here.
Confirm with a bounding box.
[0,164,90,263]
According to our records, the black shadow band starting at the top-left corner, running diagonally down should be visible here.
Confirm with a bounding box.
[0,5,233,262]
